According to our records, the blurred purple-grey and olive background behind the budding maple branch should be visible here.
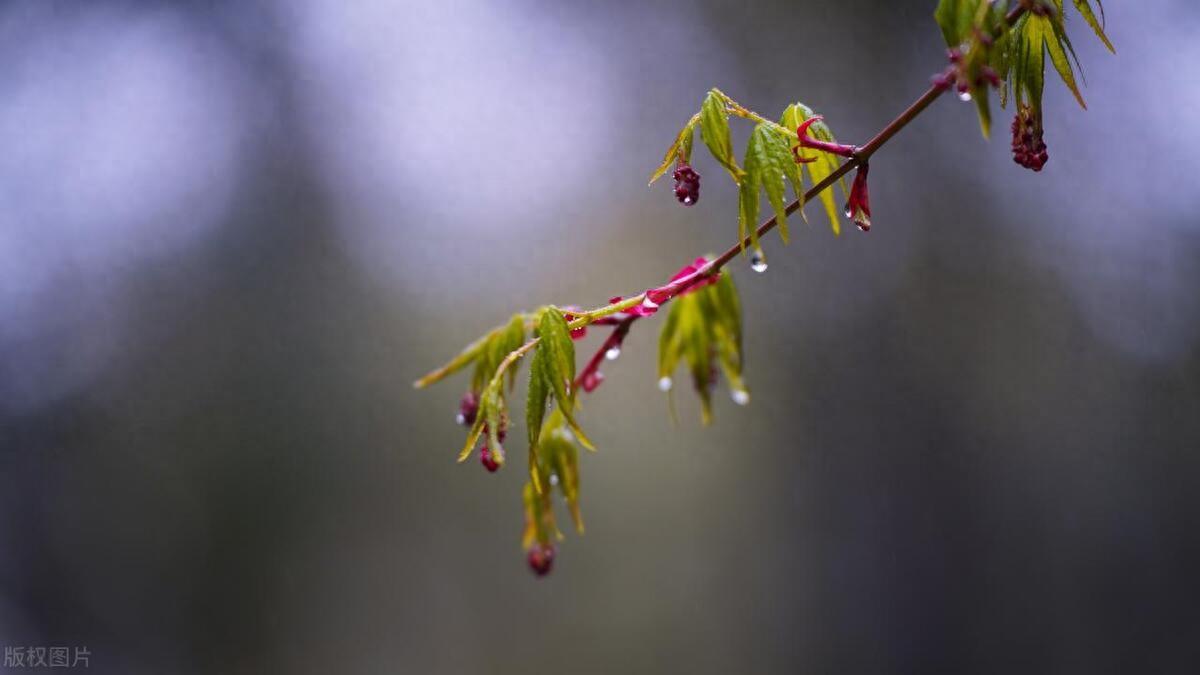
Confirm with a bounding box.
[0,0,1200,674]
